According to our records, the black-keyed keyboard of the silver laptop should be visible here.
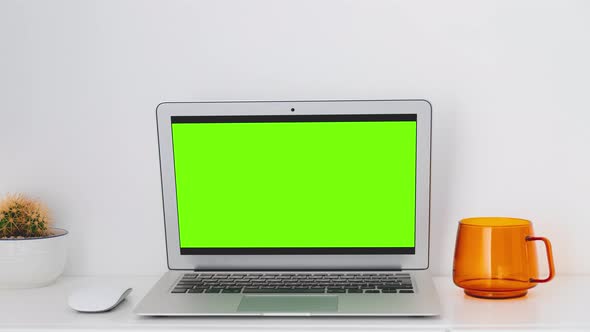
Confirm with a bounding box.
[171,272,414,294]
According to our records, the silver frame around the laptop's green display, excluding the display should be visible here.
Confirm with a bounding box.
[156,100,431,270]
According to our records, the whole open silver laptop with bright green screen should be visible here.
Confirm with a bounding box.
[135,100,440,316]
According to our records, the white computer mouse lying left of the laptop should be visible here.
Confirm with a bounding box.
[68,286,133,312]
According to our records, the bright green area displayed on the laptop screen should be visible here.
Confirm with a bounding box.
[172,121,416,248]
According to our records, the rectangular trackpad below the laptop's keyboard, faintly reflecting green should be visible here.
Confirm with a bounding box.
[238,295,338,313]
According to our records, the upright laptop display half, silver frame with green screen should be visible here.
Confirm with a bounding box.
[156,100,432,270]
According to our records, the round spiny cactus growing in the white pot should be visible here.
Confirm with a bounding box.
[0,194,51,238]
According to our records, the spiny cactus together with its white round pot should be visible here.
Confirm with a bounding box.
[0,194,68,288]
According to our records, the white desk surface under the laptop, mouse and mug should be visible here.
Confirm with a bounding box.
[0,277,590,332]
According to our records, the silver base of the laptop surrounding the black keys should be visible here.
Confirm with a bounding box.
[134,270,440,316]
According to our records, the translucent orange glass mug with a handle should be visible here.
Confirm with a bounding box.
[453,217,555,299]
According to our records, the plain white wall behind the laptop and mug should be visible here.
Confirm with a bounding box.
[0,0,590,274]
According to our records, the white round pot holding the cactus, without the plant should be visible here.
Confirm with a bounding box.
[0,228,68,288]
